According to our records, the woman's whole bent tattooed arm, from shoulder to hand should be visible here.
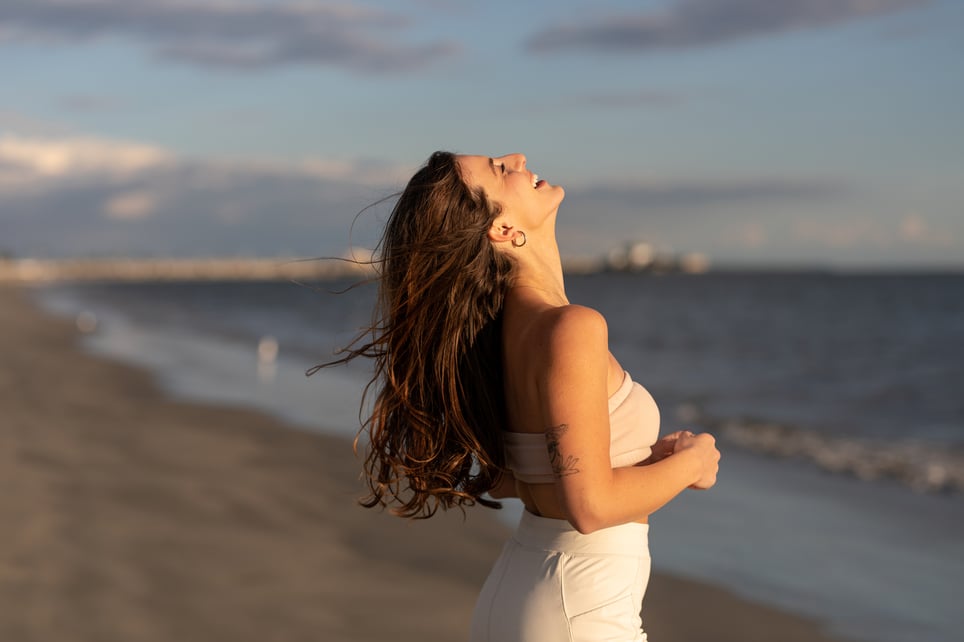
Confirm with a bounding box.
[540,306,719,533]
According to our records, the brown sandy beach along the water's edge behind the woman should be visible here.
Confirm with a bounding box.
[0,287,860,642]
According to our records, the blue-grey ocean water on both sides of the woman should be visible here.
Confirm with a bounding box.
[30,273,964,642]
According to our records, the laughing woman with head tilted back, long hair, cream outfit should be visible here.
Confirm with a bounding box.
[328,152,719,642]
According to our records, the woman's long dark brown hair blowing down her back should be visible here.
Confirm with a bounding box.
[322,152,513,518]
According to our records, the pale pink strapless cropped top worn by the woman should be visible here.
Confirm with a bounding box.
[502,371,659,484]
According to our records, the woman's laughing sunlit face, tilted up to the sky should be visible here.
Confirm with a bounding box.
[457,154,566,230]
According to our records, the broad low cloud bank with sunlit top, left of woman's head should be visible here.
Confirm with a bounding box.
[0,135,412,257]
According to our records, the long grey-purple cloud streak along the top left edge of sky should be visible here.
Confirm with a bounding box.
[0,0,458,72]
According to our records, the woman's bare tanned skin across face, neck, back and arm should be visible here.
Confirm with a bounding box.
[458,154,720,533]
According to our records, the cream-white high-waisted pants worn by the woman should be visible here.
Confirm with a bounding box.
[469,511,650,642]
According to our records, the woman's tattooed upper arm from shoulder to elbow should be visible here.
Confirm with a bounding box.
[541,306,612,530]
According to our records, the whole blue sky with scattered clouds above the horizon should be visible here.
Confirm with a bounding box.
[0,0,964,268]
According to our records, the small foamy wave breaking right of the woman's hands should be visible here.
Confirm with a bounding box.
[676,406,964,493]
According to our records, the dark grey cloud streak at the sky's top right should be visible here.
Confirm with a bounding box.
[526,0,930,53]
